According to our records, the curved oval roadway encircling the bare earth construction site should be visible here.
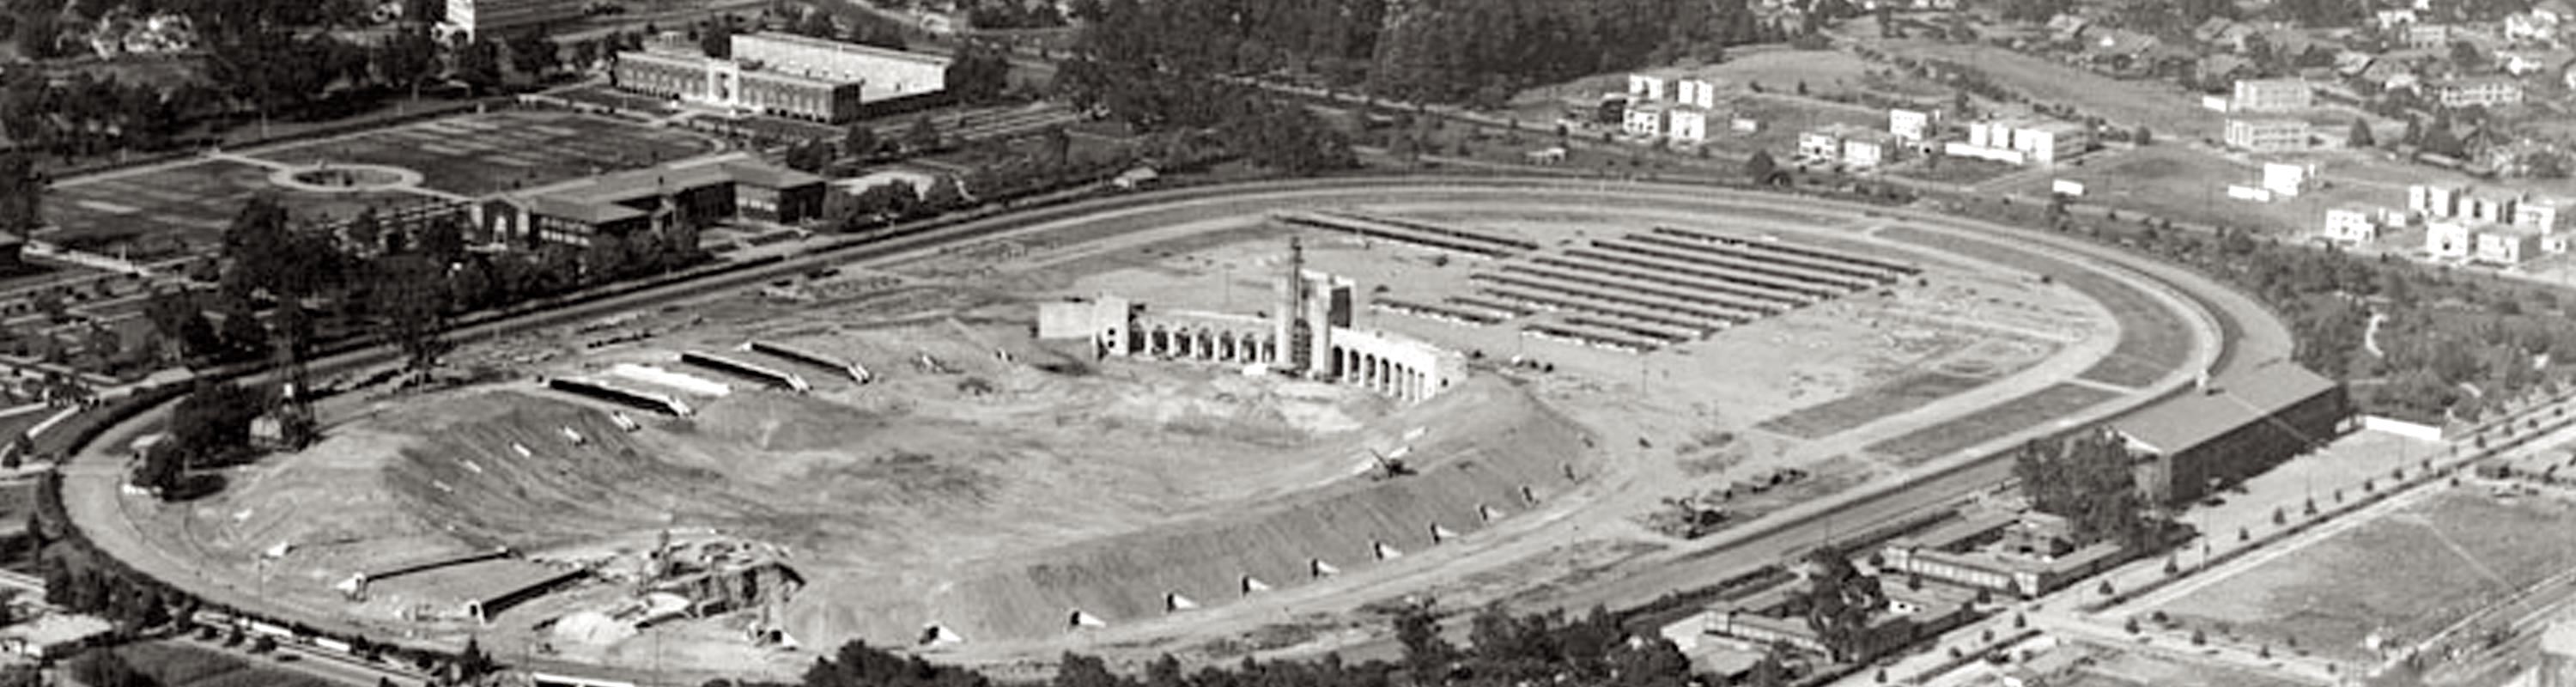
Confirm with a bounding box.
[62,178,2290,679]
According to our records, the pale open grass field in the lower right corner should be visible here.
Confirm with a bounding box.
[2161,489,2576,659]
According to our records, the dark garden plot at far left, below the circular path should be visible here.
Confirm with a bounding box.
[36,160,420,260]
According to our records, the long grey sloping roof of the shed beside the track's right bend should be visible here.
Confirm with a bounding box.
[2112,360,2334,453]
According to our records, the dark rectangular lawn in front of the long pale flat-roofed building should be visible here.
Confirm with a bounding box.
[252,111,716,196]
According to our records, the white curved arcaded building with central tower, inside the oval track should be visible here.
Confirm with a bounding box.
[1038,242,1466,401]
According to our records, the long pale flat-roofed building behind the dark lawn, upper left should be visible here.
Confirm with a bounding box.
[611,33,948,124]
